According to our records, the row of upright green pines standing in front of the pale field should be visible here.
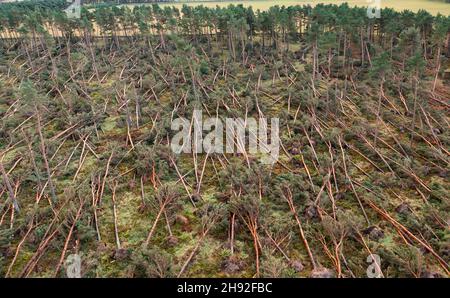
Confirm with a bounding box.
[0,0,450,58]
